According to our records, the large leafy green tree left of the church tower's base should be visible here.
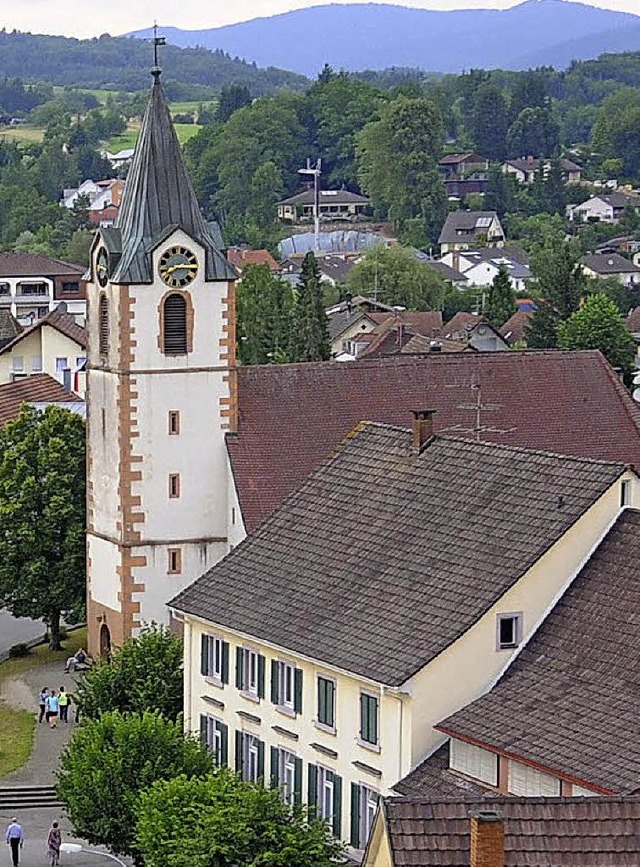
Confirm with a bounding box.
[0,405,86,649]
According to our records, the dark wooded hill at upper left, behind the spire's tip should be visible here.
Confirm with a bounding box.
[0,31,306,96]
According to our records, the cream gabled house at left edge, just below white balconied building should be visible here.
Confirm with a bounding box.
[0,302,87,396]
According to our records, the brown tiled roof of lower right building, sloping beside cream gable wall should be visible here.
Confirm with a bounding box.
[439,510,640,796]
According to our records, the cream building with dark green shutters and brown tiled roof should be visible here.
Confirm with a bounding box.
[170,420,640,849]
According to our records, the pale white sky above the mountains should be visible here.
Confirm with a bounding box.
[0,0,640,36]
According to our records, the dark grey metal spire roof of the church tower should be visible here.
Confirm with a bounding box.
[112,69,236,283]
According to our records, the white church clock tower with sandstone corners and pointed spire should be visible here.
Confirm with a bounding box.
[87,69,236,654]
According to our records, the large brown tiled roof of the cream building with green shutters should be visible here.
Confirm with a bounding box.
[169,423,624,685]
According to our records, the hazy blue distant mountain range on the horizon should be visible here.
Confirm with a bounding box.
[129,0,640,76]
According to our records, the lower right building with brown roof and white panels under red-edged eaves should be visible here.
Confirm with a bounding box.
[395,508,640,797]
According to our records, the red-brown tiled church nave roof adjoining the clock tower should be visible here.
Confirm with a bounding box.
[227,350,640,532]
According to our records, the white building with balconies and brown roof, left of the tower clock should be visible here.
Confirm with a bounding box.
[0,252,87,325]
